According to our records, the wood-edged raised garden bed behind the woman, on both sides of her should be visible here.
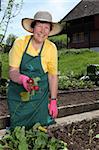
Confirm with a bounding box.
[0,88,99,128]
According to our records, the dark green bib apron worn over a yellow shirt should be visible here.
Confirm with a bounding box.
[8,36,54,128]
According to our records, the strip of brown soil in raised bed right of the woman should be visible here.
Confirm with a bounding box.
[58,88,99,106]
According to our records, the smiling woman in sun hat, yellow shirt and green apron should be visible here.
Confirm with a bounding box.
[8,11,63,128]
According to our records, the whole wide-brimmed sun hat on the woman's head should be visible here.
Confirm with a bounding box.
[22,11,63,36]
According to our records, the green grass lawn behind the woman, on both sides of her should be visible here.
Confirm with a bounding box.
[0,49,99,78]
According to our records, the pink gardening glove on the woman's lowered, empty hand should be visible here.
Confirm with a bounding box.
[48,100,58,118]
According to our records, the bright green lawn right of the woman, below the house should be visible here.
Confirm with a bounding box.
[59,50,99,75]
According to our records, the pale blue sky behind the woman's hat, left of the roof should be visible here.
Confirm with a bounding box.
[1,0,81,36]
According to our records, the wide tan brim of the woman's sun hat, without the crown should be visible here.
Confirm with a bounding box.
[21,18,64,36]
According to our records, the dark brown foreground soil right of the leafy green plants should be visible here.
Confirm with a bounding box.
[51,118,99,150]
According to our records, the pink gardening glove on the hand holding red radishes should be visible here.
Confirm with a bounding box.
[19,75,31,92]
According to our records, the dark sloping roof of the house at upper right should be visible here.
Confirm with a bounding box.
[61,0,99,22]
